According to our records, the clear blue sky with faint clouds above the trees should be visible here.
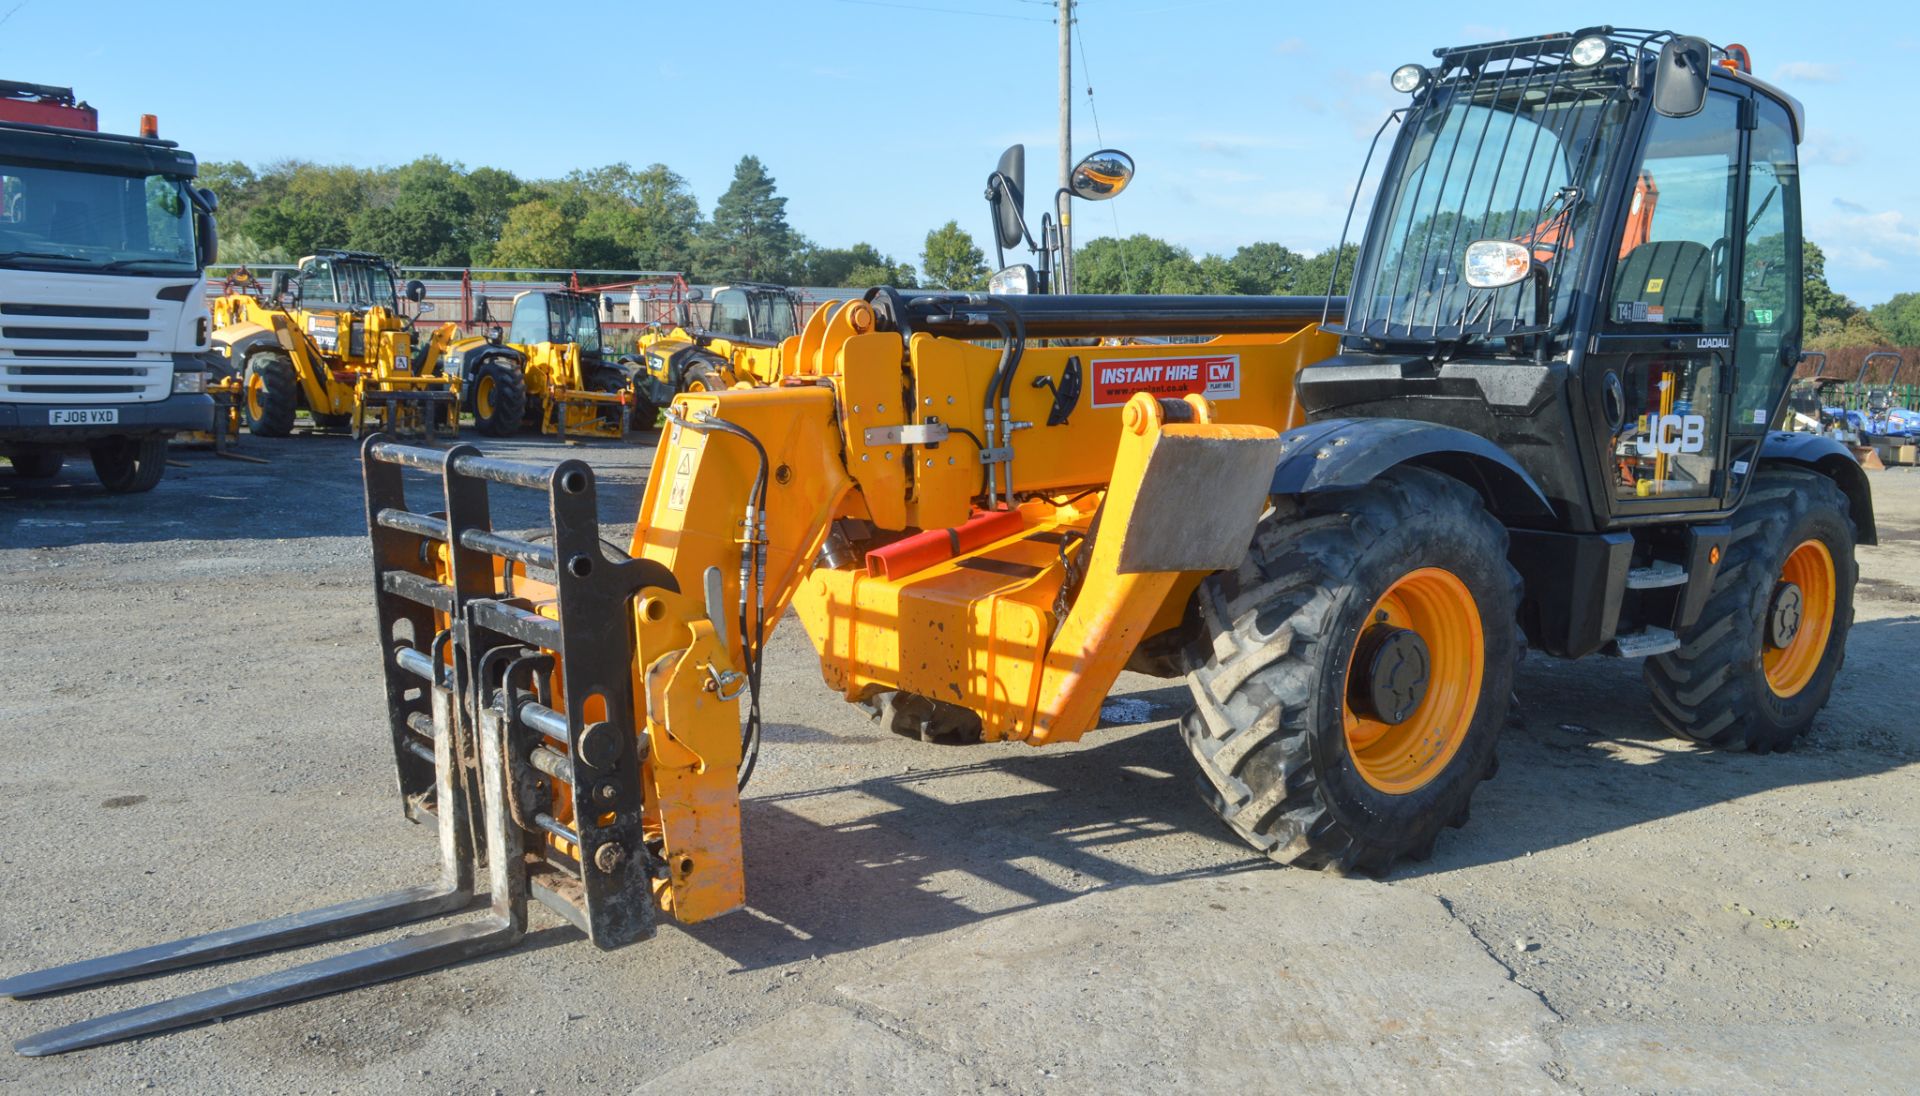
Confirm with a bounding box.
[0,0,1920,303]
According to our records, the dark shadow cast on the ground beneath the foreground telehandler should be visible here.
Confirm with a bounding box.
[689,616,1920,969]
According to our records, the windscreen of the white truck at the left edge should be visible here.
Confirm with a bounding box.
[0,161,200,274]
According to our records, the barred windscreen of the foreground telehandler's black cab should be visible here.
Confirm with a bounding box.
[1346,50,1628,340]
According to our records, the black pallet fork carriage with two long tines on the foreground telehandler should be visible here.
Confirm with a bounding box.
[0,436,678,1058]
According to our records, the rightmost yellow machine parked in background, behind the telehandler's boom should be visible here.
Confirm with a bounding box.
[637,282,802,407]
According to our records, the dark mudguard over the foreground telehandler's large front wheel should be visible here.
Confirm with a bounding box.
[1273,418,1553,520]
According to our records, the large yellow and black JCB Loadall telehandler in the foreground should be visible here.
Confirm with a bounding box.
[0,27,1874,1054]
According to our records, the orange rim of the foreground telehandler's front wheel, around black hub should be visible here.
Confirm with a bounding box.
[1340,566,1486,795]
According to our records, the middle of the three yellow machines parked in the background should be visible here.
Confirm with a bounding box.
[444,290,659,440]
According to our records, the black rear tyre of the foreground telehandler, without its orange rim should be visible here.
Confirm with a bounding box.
[1644,466,1860,754]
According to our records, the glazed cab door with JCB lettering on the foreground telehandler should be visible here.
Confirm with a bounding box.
[1582,88,1749,518]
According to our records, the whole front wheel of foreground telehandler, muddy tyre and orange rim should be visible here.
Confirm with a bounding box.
[1181,468,1521,873]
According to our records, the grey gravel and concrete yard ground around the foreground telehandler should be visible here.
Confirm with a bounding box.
[0,438,1920,1094]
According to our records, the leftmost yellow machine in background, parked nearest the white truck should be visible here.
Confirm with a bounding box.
[211,251,459,438]
